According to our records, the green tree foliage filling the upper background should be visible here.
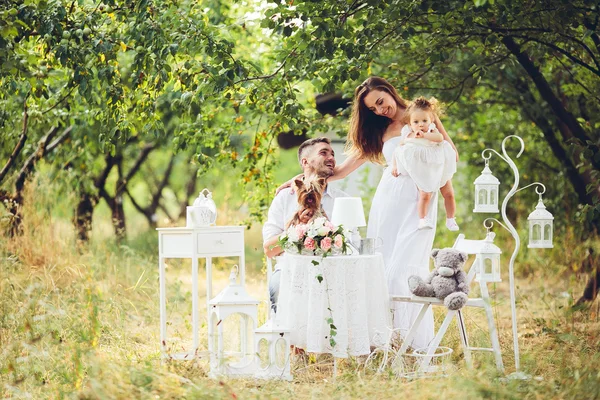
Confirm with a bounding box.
[0,0,600,241]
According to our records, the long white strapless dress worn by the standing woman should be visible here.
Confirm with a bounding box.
[367,136,438,347]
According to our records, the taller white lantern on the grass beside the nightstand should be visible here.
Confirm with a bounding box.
[208,265,258,378]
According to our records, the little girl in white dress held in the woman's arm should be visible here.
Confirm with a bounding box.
[392,97,459,231]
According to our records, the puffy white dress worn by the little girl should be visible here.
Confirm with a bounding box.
[394,124,456,192]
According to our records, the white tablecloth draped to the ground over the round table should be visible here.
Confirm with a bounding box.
[276,253,391,358]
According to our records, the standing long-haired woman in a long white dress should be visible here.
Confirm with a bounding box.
[329,76,458,347]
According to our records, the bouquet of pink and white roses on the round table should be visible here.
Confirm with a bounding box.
[277,217,348,256]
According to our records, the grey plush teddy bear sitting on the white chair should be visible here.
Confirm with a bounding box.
[408,248,469,310]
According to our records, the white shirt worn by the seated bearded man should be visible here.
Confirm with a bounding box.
[263,185,348,242]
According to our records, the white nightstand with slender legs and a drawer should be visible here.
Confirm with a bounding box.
[157,226,246,360]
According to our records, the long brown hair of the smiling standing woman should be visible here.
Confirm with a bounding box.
[346,76,408,164]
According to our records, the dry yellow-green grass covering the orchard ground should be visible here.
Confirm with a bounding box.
[0,179,600,399]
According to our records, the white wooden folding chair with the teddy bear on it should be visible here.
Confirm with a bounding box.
[391,234,504,372]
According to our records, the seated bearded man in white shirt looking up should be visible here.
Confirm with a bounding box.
[263,137,348,310]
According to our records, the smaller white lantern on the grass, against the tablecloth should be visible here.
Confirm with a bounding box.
[254,310,292,381]
